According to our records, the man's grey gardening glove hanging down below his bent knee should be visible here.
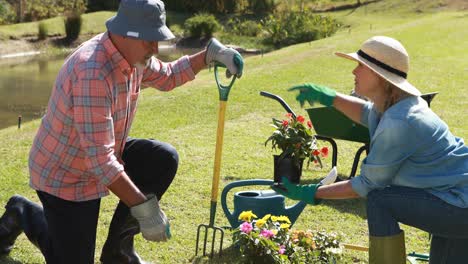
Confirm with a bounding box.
[130,195,171,241]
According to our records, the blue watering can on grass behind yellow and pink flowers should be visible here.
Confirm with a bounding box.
[221,179,307,228]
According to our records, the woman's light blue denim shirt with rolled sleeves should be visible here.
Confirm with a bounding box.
[351,96,468,208]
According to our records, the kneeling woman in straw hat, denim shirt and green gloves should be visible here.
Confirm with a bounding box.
[275,36,468,264]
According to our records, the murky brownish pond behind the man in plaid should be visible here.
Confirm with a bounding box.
[0,49,197,129]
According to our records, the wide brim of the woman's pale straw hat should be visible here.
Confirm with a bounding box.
[335,52,421,96]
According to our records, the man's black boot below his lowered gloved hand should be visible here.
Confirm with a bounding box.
[100,202,146,264]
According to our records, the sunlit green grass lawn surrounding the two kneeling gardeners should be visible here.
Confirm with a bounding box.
[0,2,468,263]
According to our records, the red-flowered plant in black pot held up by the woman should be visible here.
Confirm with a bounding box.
[265,113,328,183]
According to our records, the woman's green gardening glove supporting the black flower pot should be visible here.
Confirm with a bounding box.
[271,177,321,205]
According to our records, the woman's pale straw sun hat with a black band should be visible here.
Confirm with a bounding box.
[335,36,421,96]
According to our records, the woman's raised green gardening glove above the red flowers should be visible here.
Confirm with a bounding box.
[288,83,336,107]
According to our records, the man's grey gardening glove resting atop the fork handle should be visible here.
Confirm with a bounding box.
[205,38,244,78]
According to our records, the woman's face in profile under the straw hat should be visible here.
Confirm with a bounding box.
[353,63,384,100]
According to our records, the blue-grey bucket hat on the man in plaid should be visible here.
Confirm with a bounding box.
[106,0,175,41]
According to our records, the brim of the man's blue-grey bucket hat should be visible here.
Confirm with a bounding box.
[106,15,175,41]
